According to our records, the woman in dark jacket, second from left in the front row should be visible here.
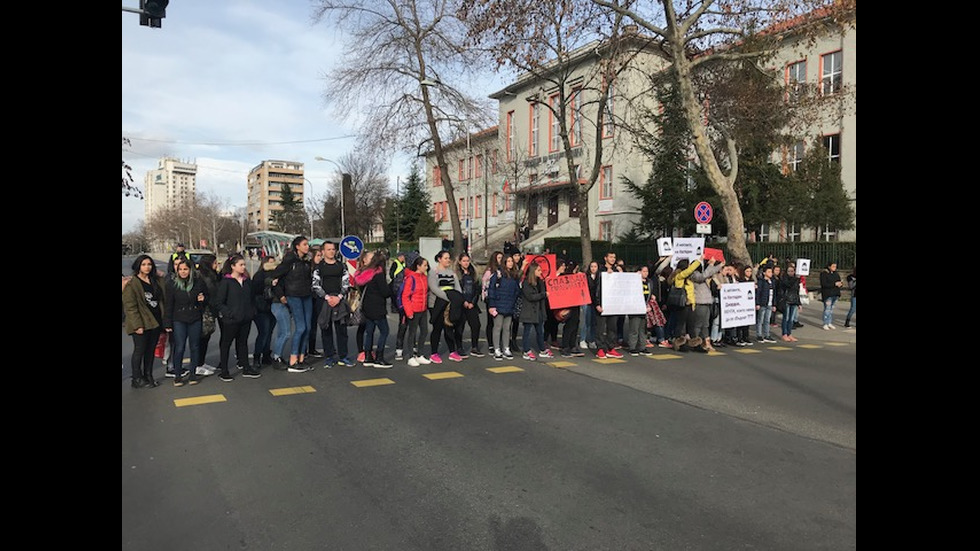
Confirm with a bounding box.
[163,258,208,387]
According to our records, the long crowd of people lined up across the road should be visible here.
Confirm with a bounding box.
[122,236,857,388]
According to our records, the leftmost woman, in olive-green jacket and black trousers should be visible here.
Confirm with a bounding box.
[122,254,167,388]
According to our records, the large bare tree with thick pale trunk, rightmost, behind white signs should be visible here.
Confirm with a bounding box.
[591,0,854,263]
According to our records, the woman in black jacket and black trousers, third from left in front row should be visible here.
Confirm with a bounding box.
[213,254,262,382]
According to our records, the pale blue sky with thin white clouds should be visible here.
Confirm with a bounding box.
[122,0,512,233]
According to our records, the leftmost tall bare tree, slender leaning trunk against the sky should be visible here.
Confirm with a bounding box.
[313,0,492,256]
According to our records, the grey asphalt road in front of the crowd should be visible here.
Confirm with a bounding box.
[122,304,856,550]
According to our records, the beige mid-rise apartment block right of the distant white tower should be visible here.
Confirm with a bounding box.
[248,161,306,231]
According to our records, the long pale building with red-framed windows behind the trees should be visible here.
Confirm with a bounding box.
[426,6,857,250]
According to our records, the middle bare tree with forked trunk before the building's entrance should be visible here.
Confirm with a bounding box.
[461,0,635,263]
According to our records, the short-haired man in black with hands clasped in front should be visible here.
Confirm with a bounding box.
[313,241,354,369]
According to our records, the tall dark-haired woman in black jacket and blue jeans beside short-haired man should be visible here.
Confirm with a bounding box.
[268,235,313,373]
